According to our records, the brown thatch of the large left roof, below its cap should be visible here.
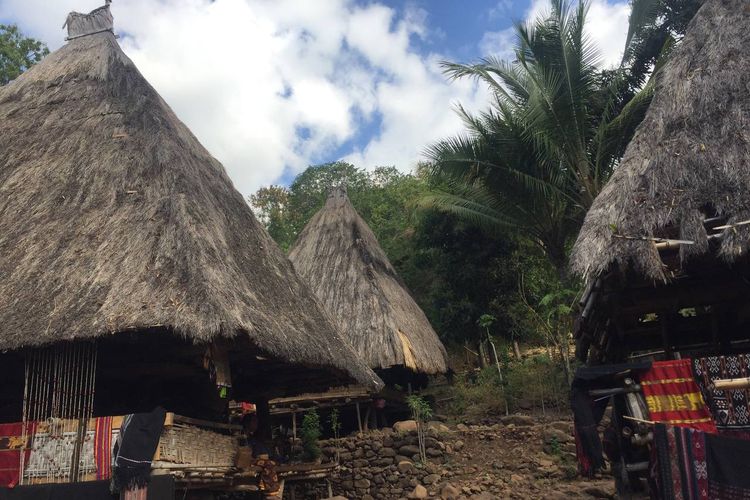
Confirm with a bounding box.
[0,32,380,387]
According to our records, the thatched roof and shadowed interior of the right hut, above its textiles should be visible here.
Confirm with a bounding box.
[572,0,750,363]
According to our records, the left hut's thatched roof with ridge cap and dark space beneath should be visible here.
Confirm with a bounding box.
[0,4,382,494]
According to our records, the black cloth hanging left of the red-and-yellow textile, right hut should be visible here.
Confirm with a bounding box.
[570,362,651,476]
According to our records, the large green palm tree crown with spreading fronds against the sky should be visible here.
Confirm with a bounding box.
[422,0,652,276]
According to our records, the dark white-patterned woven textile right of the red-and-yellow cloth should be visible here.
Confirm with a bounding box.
[693,354,750,431]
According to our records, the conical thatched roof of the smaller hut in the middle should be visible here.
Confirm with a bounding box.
[289,188,446,374]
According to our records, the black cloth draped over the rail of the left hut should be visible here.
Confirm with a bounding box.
[112,407,167,491]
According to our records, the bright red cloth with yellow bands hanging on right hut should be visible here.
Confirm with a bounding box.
[641,359,716,434]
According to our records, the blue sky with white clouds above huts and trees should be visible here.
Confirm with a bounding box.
[0,0,629,195]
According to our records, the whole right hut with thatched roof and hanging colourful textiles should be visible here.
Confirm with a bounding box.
[572,0,750,492]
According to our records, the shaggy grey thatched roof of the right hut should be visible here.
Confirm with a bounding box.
[572,0,750,280]
